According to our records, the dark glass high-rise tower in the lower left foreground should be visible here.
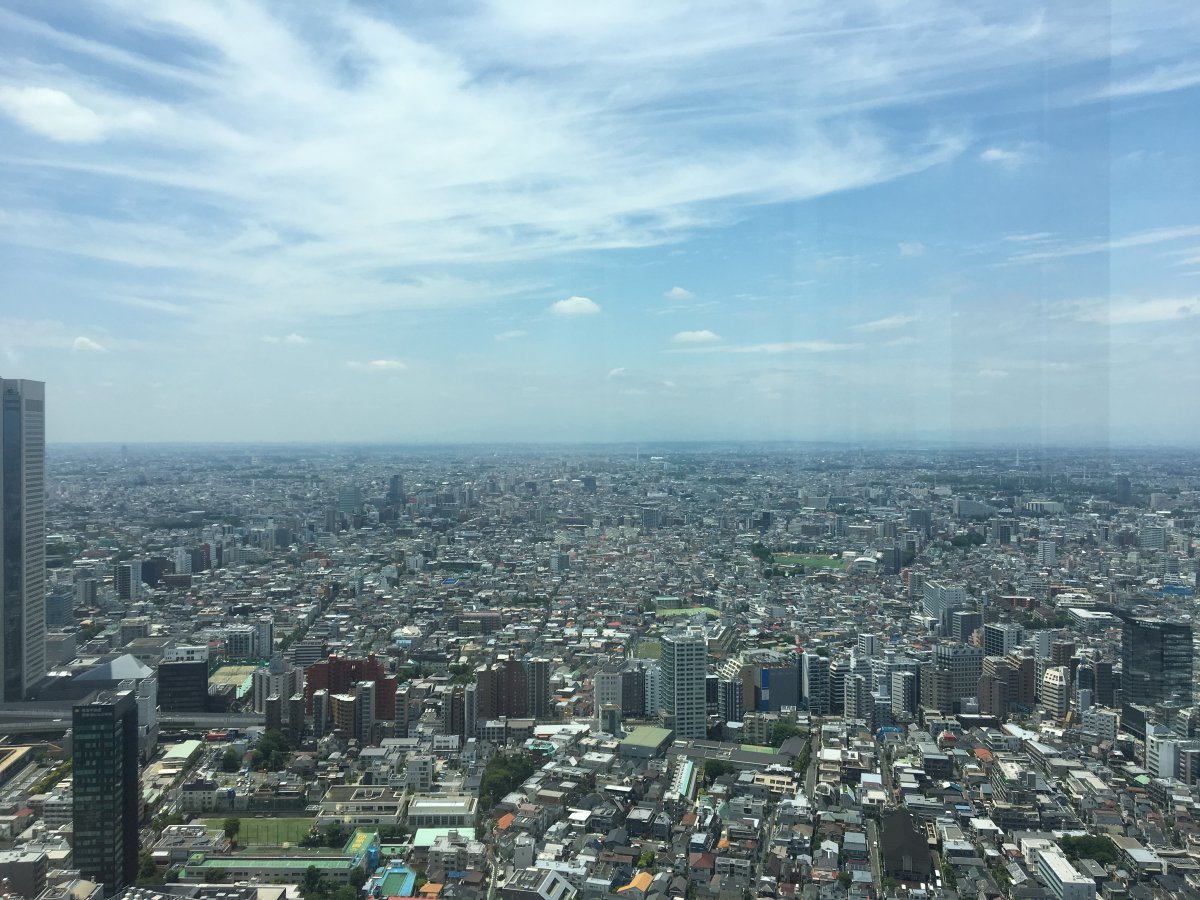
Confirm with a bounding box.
[71,691,142,896]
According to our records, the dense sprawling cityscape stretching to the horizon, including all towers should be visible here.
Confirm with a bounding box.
[0,379,1200,900]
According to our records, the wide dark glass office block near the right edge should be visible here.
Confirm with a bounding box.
[1121,618,1194,706]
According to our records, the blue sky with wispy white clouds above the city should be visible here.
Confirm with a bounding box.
[0,0,1200,445]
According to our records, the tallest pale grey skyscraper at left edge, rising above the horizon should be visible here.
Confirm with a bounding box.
[0,378,46,702]
